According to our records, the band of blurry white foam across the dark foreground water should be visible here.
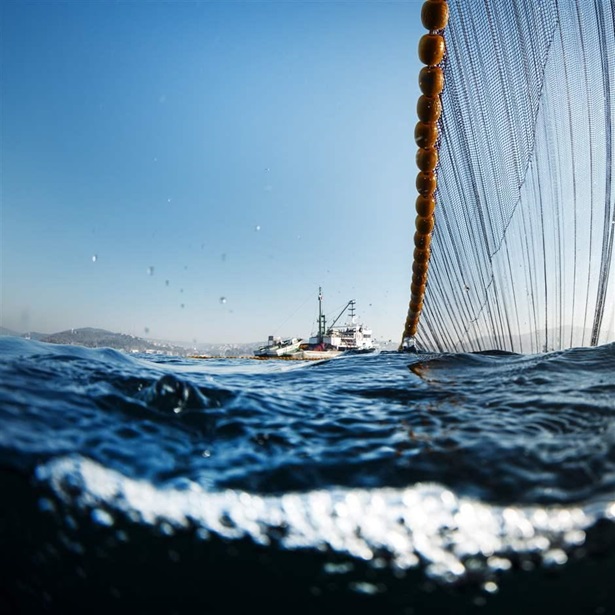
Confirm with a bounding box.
[36,456,615,583]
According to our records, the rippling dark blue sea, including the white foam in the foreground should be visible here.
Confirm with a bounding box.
[0,338,615,615]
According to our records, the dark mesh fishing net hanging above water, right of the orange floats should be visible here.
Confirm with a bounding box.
[416,0,615,353]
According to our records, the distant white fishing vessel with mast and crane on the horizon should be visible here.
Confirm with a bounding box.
[254,288,374,360]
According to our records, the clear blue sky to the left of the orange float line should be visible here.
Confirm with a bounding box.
[0,0,424,342]
